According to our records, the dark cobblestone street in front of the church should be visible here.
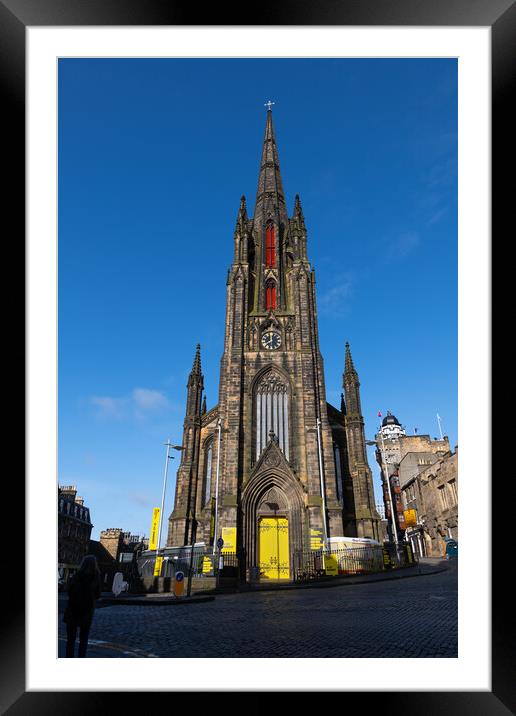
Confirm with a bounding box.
[59,566,458,658]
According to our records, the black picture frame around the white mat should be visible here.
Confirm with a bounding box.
[4,0,510,716]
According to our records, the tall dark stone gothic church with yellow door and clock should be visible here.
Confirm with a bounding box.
[167,106,380,579]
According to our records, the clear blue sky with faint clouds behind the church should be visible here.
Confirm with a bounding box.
[58,59,458,539]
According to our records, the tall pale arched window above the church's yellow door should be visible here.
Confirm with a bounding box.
[254,371,289,460]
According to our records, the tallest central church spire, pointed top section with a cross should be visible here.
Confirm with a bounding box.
[254,106,286,225]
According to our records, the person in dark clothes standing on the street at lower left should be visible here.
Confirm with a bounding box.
[64,554,100,657]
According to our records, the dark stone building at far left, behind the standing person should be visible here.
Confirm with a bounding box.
[57,485,93,584]
